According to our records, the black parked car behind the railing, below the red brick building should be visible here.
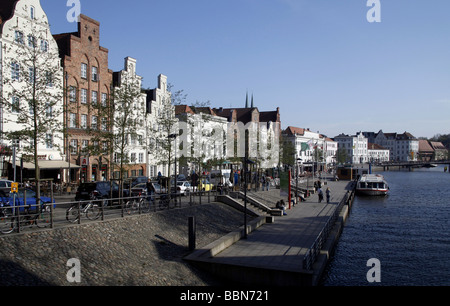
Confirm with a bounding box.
[75,182,129,201]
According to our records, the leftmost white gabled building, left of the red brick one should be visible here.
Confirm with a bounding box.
[0,0,67,181]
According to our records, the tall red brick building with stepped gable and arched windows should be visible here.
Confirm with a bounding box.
[54,15,113,182]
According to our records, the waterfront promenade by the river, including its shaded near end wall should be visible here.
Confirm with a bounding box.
[185,181,350,285]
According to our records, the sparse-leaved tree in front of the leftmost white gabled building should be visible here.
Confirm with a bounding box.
[1,21,64,201]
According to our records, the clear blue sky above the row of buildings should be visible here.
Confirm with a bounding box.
[41,0,450,137]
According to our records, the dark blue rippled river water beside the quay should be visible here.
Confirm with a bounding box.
[322,166,450,286]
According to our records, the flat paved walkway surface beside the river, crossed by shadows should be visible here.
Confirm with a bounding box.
[210,181,349,272]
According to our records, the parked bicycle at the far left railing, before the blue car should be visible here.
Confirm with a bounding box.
[0,201,51,234]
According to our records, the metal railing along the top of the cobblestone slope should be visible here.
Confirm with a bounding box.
[0,191,219,235]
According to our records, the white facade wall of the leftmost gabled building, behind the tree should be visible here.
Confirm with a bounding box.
[0,0,64,161]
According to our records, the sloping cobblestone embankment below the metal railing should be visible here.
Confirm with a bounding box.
[0,203,253,286]
